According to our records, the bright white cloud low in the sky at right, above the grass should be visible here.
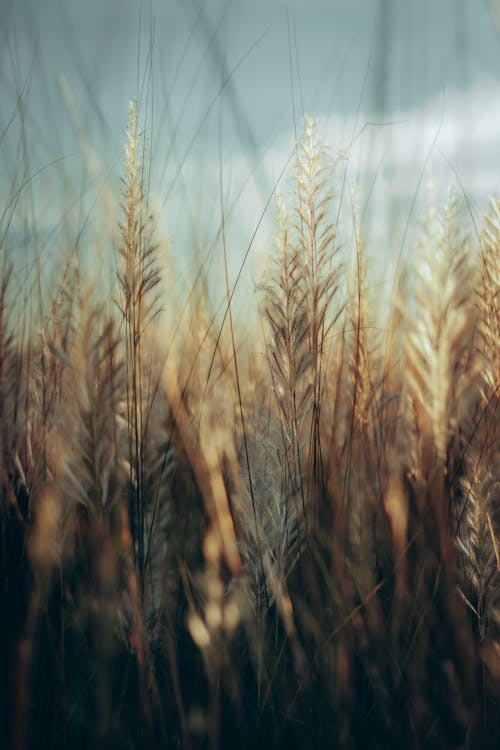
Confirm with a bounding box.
[319,78,500,209]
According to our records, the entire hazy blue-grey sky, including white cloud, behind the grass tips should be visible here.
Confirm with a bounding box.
[0,0,500,290]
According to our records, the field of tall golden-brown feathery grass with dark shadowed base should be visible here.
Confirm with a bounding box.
[0,101,500,750]
